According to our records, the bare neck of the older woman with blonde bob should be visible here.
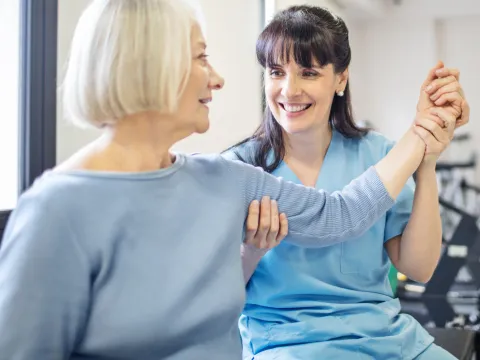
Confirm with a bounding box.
[97,113,183,172]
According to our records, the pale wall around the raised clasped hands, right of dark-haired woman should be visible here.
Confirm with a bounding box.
[349,8,480,183]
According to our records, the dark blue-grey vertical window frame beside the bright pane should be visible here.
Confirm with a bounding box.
[0,0,58,242]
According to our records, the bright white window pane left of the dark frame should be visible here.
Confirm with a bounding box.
[0,0,20,211]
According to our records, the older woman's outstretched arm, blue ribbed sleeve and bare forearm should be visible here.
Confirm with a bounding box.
[224,126,425,247]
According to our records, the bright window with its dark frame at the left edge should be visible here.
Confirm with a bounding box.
[0,0,58,241]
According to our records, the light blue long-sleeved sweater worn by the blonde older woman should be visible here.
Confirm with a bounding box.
[0,154,394,360]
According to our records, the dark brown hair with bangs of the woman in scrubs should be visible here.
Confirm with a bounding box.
[230,5,368,172]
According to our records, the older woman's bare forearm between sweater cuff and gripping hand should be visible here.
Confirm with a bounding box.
[375,129,425,199]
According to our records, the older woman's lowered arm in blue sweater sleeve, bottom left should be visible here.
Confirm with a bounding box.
[0,191,90,360]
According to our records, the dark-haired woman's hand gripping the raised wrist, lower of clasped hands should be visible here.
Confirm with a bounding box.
[413,107,456,166]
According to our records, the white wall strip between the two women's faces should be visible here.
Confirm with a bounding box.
[176,0,262,152]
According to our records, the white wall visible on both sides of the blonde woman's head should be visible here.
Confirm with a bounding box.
[57,0,262,162]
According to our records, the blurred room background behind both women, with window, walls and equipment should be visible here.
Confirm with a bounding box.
[0,0,480,356]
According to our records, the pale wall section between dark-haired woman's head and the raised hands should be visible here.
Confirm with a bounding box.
[350,19,436,139]
